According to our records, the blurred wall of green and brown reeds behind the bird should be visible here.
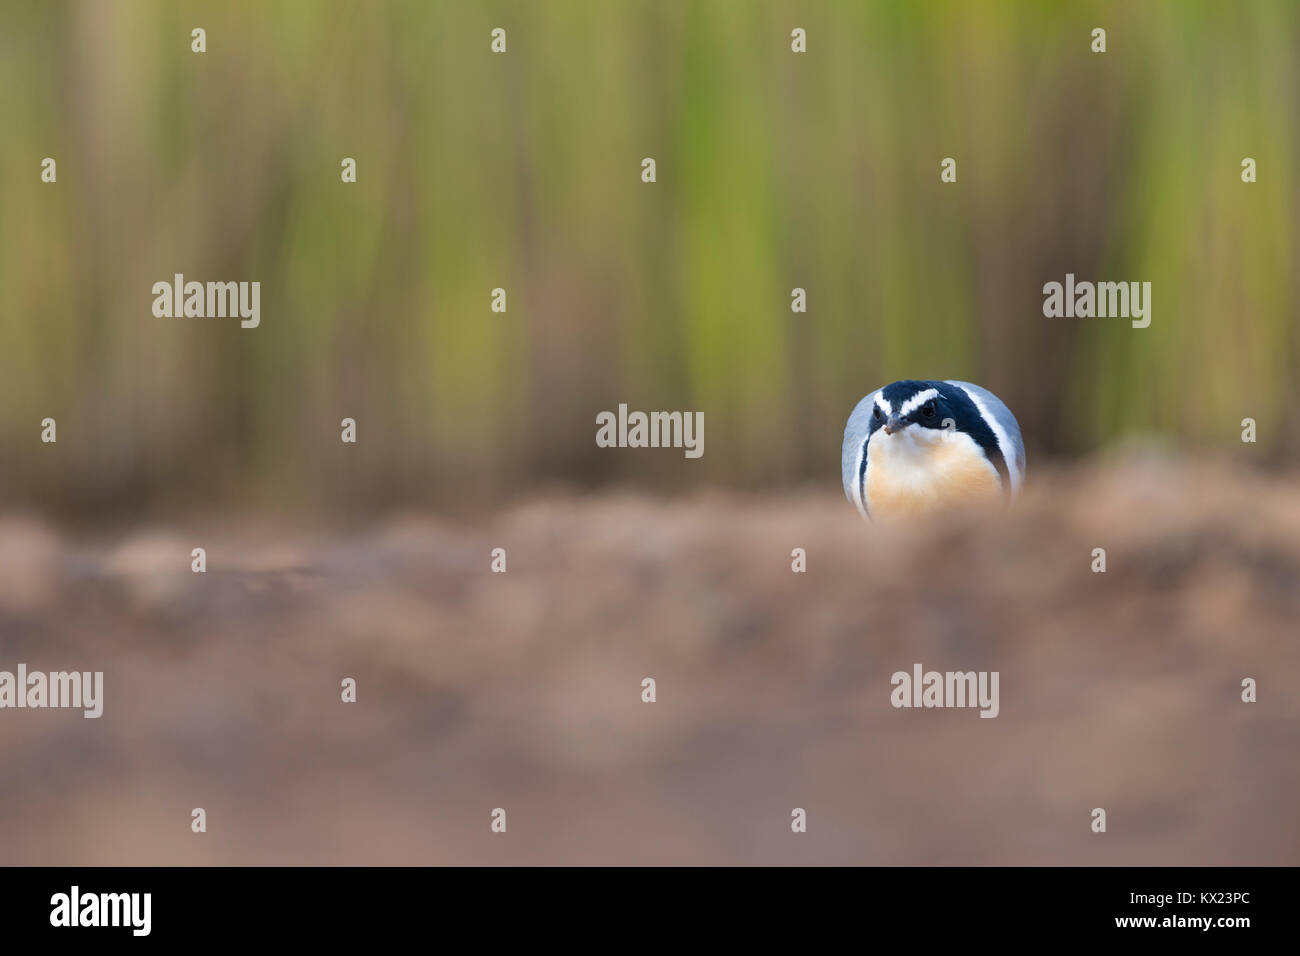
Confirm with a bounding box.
[0,0,1300,515]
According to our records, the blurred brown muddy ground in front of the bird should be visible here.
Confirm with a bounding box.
[0,457,1300,865]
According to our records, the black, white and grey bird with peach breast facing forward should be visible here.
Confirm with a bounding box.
[840,380,1024,520]
